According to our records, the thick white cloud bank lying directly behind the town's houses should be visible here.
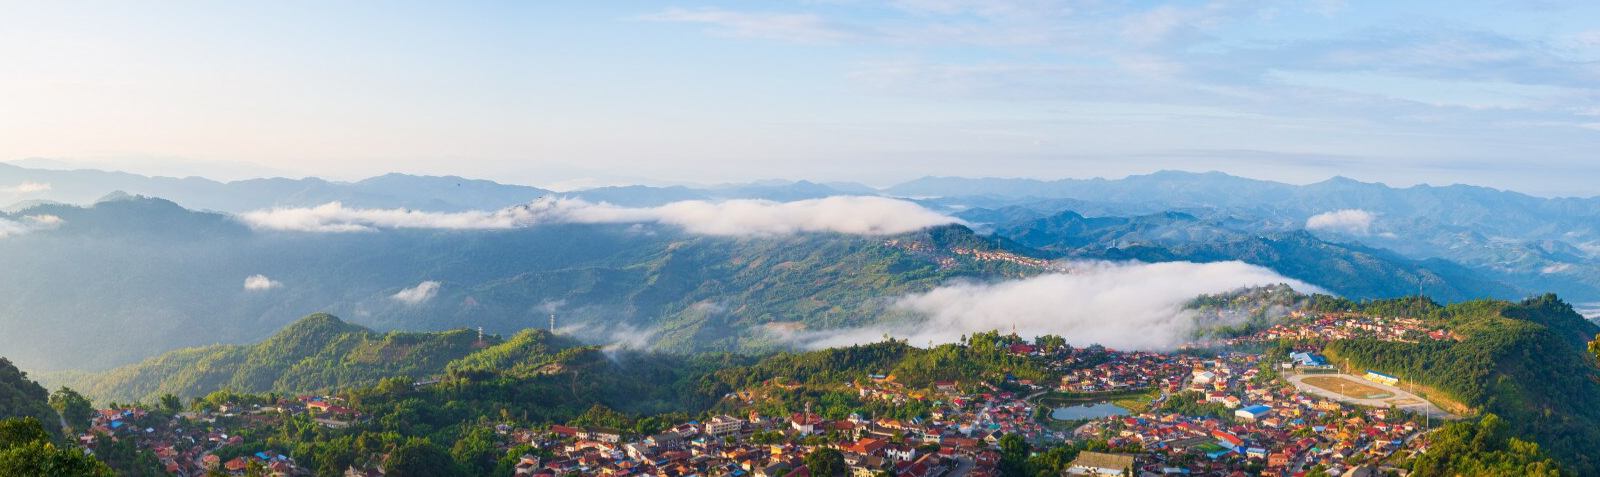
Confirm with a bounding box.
[798,261,1323,349]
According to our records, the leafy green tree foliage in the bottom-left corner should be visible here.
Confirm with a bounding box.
[0,418,112,477]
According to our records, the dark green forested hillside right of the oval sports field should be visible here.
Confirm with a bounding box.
[1320,295,1600,475]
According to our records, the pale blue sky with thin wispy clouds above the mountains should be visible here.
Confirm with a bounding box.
[0,0,1600,197]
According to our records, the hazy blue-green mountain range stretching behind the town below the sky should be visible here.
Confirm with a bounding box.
[0,165,1600,370]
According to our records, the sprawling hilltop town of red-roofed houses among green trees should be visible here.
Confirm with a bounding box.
[59,302,1484,477]
